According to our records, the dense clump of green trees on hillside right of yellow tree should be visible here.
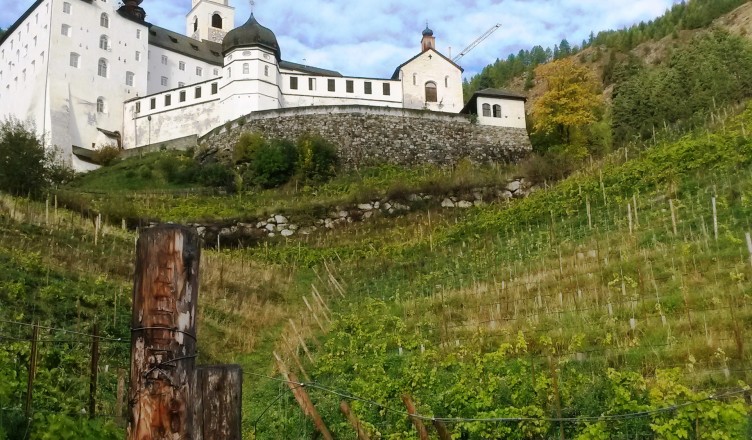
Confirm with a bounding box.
[612,30,752,142]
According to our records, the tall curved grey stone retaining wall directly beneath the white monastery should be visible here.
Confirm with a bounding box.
[199,105,532,168]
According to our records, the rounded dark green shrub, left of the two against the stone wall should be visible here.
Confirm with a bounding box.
[253,139,297,188]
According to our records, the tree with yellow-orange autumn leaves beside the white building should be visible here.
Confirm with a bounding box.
[532,58,603,144]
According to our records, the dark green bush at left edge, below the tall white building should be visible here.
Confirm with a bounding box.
[0,118,73,195]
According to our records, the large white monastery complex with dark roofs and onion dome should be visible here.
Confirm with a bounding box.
[0,0,525,171]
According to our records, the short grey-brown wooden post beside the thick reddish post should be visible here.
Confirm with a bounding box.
[191,365,243,440]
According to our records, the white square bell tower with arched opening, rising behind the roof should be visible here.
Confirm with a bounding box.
[185,0,235,43]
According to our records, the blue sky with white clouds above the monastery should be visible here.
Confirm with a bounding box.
[0,0,680,78]
